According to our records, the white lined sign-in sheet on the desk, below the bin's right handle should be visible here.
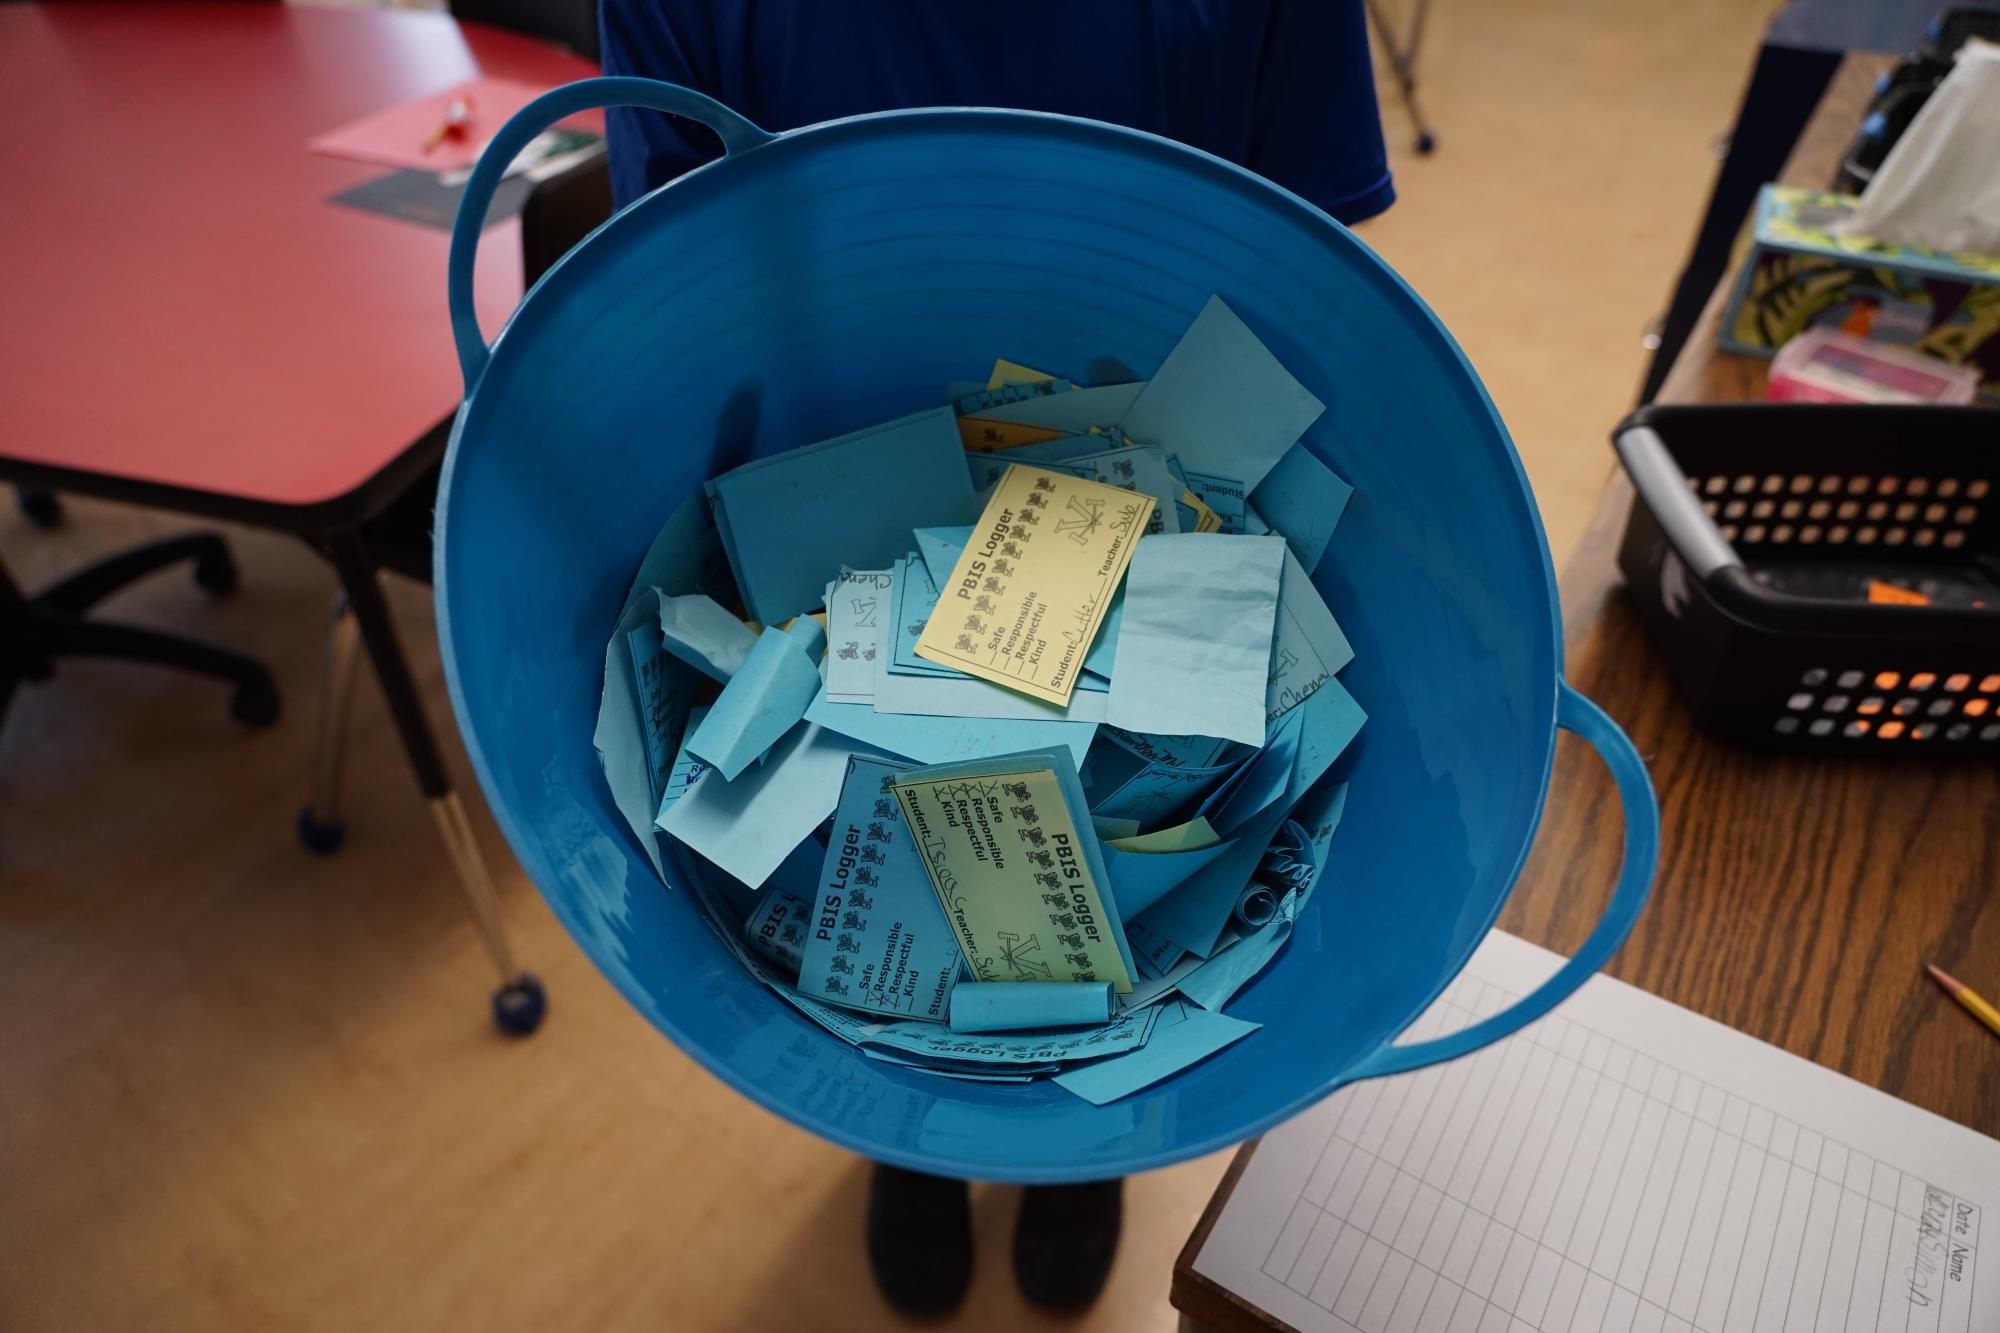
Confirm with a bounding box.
[1194,931,2000,1333]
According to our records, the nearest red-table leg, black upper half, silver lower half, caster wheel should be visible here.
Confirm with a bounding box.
[324,532,548,1035]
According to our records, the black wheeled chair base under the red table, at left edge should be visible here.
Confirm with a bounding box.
[0,532,280,727]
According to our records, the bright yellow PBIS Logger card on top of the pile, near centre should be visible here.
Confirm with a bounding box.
[916,462,1154,707]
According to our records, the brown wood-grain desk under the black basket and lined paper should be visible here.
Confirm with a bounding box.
[1172,46,2000,1333]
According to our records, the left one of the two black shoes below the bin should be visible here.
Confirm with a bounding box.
[868,1163,972,1319]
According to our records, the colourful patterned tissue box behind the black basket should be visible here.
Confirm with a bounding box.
[1722,184,2000,400]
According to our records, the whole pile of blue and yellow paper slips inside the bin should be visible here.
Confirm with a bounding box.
[596,298,1364,1103]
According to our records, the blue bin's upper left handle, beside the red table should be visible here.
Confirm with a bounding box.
[444,78,776,398]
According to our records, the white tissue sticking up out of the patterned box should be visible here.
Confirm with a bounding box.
[1836,38,2000,254]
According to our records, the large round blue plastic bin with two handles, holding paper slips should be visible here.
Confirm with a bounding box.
[436,78,1658,1181]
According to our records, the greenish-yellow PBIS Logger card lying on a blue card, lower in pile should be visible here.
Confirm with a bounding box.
[894,769,1132,995]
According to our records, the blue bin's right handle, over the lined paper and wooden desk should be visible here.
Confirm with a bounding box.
[1348,683,1660,1079]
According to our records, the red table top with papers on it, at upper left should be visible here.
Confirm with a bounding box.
[0,4,596,504]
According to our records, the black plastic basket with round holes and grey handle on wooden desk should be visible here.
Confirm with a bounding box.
[1612,404,2000,763]
